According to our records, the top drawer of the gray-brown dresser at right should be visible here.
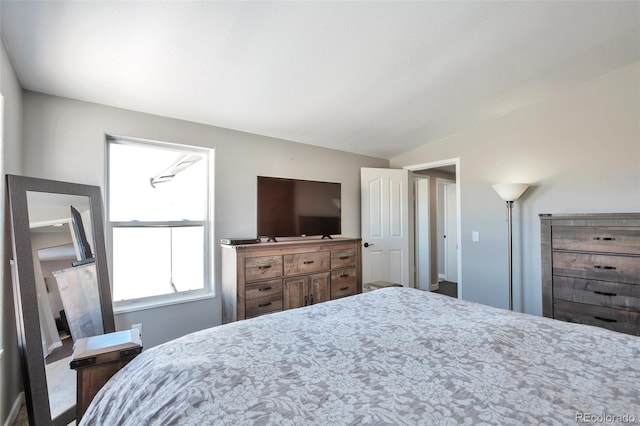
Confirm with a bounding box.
[552,226,640,254]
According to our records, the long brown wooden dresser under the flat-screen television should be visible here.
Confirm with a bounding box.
[222,238,362,323]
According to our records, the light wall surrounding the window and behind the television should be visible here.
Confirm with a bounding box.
[23,92,389,347]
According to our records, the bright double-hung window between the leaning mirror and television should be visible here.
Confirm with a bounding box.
[107,137,213,310]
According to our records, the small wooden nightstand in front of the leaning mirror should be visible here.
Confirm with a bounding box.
[69,329,142,423]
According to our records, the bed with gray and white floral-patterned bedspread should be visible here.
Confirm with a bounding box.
[81,288,640,425]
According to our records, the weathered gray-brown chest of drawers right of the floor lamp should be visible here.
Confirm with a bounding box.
[540,213,640,336]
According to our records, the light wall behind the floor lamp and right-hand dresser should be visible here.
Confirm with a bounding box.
[391,62,640,315]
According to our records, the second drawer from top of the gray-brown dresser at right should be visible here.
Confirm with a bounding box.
[553,252,640,284]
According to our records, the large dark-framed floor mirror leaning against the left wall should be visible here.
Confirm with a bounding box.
[7,175,115,426]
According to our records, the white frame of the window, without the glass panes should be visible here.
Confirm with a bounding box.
[105,134,216,314]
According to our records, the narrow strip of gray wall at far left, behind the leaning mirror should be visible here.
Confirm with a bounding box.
[0,41,22,424]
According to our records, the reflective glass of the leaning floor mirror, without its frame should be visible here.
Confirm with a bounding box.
[27,191,104,418]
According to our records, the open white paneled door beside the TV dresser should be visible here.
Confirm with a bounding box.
[360,168,413,287]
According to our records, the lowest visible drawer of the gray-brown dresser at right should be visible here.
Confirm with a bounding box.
[553,299,640,336]
